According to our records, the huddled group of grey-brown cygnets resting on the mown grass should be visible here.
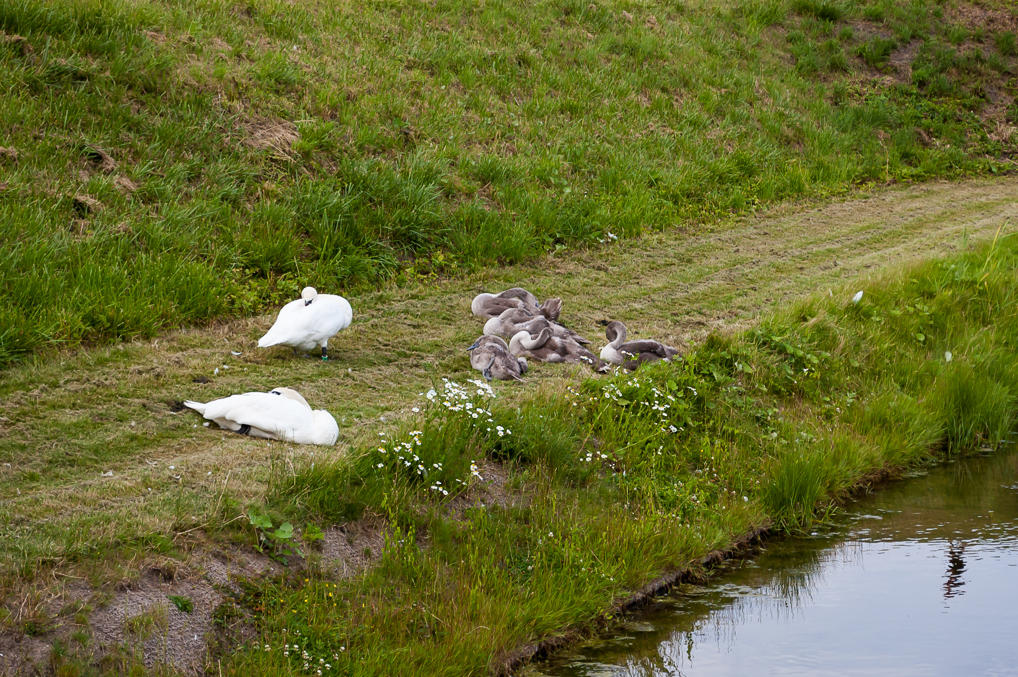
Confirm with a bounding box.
[467,287,678,381]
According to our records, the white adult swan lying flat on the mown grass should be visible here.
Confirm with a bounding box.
[184,388,339,445]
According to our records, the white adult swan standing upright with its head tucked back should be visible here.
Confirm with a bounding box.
[258,287,353,359]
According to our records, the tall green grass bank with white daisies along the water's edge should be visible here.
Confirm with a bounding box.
[202,235,1018,675]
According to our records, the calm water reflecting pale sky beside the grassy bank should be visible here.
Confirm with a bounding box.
[525,449,1018,677]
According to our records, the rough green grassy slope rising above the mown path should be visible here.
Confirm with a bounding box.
[0,0,1018,365]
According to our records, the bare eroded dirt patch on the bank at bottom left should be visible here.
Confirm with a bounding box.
[0,549,282,675]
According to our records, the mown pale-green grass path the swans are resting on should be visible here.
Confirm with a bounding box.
[0,179,1018,595]
